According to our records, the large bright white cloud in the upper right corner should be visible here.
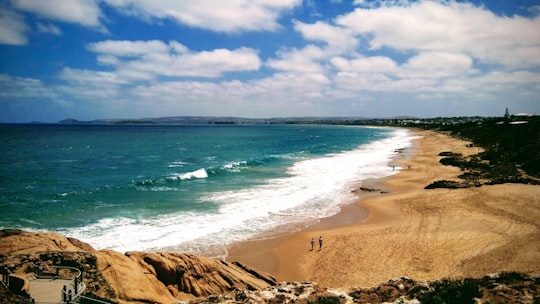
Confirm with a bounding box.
[336,1,540,67]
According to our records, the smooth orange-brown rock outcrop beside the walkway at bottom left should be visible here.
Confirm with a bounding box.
[0,230,276,303]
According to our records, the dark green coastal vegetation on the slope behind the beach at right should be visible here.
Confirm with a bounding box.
[421,116,540,189]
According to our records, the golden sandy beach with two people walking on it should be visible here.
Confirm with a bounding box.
[227,130,540,288]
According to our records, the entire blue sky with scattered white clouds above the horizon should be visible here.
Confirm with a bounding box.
[0,0,540,122]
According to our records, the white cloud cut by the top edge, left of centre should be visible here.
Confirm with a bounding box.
[105,0,302,33]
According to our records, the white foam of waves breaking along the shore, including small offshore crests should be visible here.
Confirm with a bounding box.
[65,129,413,255]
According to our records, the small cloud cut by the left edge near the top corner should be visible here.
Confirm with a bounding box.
[0,7,28,45]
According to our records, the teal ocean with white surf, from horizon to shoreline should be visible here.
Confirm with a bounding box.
[0,124,412,256]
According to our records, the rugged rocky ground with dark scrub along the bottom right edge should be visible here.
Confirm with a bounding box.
[190,272,540,304]
